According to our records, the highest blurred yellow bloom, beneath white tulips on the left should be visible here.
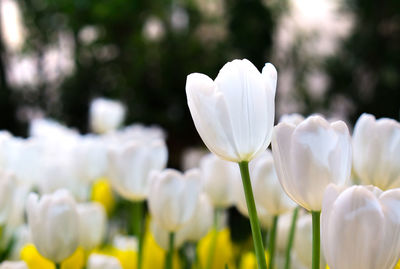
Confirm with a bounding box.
[91,178,115,214]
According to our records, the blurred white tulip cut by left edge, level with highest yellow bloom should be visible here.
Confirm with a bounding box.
[0,171,17,226]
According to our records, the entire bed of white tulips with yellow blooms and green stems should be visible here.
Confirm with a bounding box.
[0,60,400,269]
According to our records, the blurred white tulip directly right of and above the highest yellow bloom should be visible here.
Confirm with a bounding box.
[109,139,168,201]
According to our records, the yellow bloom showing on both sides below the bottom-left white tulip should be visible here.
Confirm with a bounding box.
[21,244,85,269]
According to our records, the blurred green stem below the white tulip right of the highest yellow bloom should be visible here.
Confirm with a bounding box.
[132,201,144,269]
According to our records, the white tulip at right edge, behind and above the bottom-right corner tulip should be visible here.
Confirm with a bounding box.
[353,114,400,190]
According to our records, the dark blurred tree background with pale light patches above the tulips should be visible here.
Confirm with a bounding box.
[0,0,400,167]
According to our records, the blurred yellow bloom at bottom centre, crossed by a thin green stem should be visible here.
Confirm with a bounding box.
[197,229,235,269]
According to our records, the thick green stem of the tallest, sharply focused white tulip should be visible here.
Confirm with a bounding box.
[239,161,267,269]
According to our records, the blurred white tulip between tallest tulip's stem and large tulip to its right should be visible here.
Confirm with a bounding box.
[250,150,296,216]
